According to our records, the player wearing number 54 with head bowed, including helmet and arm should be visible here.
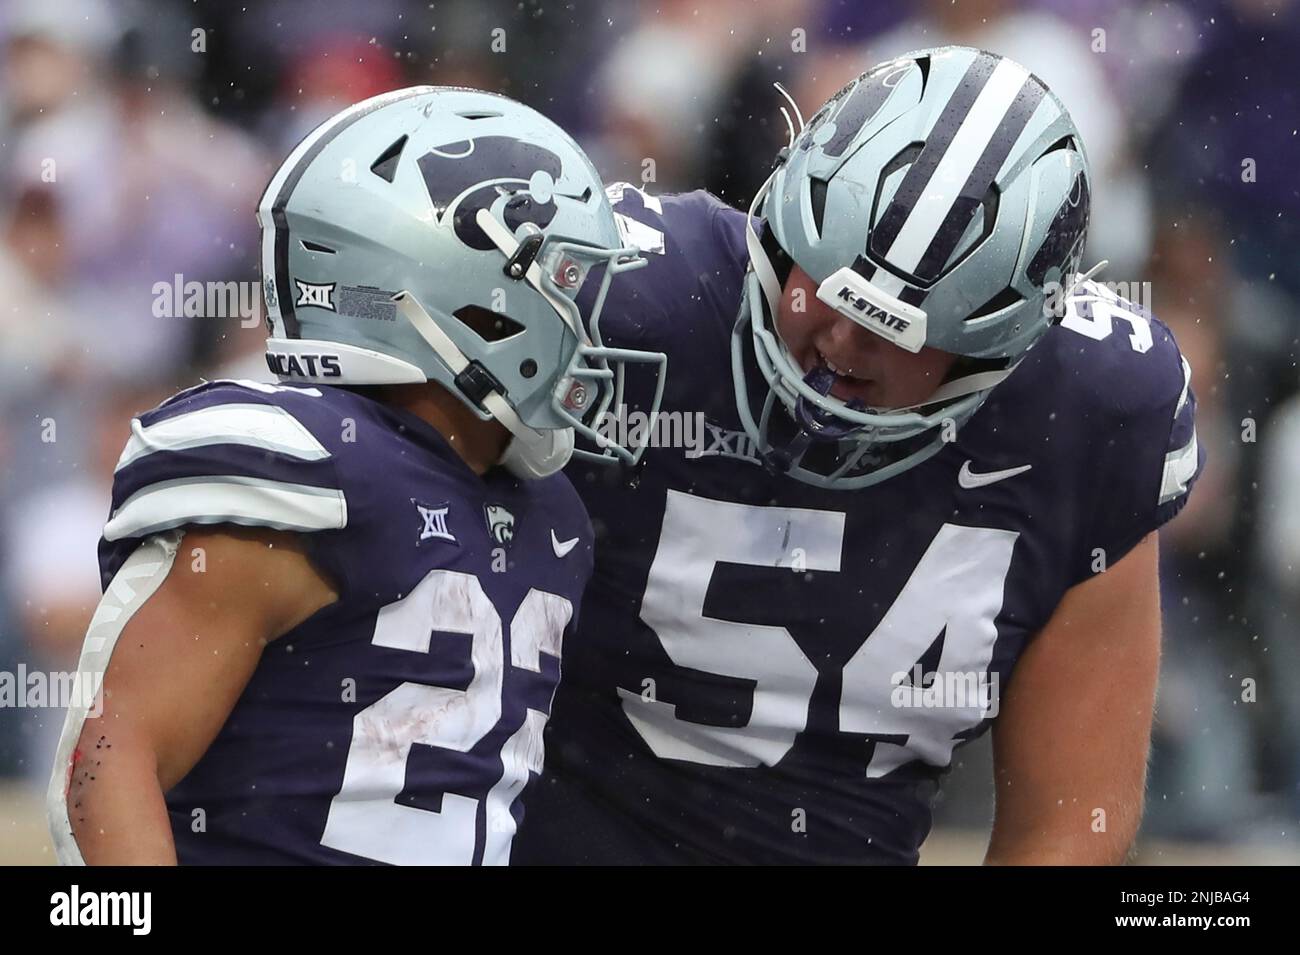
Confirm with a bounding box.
[516,47,1203,864]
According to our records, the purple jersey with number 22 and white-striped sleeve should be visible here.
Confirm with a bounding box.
[100,382,592,864]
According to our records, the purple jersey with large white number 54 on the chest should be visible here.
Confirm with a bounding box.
[515,187,1203,863]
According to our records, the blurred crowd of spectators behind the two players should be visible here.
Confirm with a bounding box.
[0,0,1300,861]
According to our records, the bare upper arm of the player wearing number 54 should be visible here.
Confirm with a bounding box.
[985,533,1160,865]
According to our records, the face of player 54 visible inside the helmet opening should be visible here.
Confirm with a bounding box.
[776,265,956,408]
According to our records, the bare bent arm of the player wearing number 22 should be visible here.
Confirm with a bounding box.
[68,526,337,865]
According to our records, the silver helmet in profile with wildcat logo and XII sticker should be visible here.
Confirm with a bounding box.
[259,87,666,477]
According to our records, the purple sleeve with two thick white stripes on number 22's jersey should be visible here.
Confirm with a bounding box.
[100,382,347,586]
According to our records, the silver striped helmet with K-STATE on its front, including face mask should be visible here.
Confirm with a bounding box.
[732,47,1088,489]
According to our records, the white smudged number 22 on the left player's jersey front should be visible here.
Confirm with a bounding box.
[321,568,573,865]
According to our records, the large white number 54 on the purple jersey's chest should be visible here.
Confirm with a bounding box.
[619,490,1018,776]
